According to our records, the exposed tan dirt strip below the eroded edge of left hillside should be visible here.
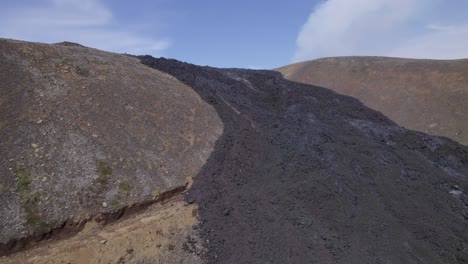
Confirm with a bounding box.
[0,195,203,264]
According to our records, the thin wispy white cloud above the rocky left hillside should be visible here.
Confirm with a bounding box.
[0,0,170,56]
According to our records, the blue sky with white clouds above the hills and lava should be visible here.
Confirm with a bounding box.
[0,0,468,69]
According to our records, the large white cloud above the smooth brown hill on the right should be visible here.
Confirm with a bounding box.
[293,0,468,61]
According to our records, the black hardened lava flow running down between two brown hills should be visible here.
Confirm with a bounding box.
[141,57,468,264]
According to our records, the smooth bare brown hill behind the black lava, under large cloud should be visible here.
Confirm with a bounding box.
[277,57,468,145]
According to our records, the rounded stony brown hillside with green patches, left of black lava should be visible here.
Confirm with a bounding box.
[0,39,223,244]
